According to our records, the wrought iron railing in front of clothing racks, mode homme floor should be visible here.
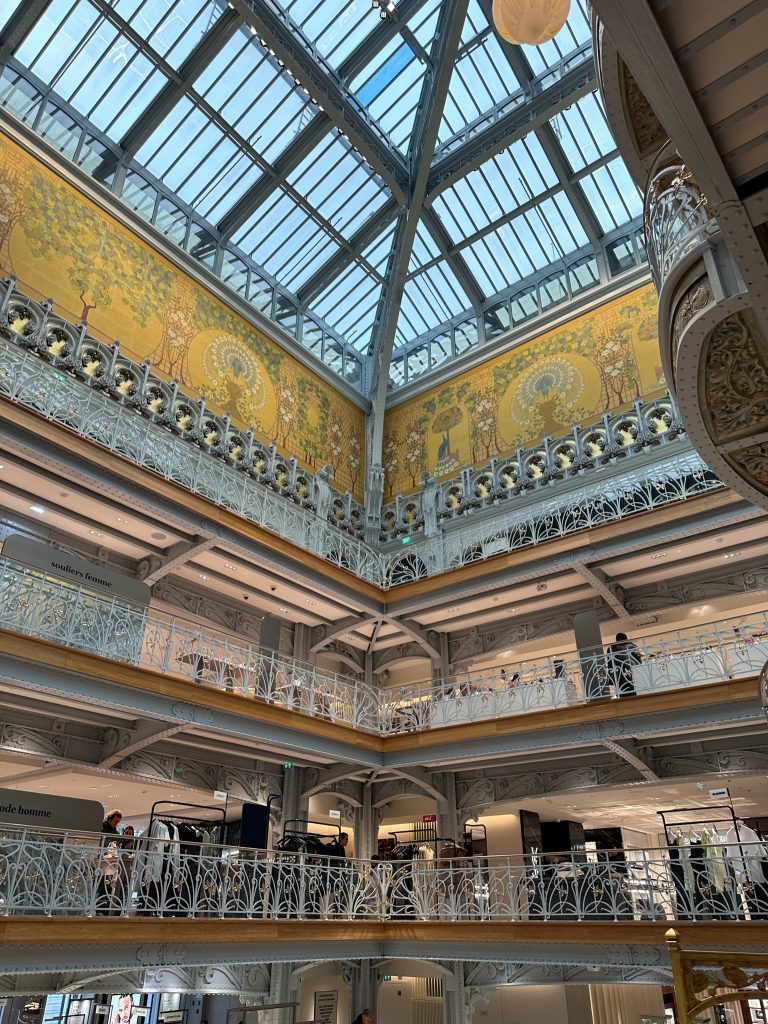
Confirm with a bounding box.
[0,825,768,922]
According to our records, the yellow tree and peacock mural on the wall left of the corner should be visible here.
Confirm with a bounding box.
[0,137,365,498]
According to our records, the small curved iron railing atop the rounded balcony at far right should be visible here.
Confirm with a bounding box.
[644,142,714,291]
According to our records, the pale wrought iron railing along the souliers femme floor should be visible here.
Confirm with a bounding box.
[0,558,768,736]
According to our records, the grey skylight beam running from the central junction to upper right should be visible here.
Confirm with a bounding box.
[427,55,597,200]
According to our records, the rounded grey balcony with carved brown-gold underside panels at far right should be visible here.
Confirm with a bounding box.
[645,144,768,508]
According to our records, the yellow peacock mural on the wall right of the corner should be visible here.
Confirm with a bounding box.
[383,285,666,499]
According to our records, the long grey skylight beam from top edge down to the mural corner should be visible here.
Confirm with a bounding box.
[367,0,469,432]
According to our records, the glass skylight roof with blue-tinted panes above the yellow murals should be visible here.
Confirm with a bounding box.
[0,0,641,384]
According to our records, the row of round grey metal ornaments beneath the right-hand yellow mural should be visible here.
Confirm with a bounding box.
[381,393,686,542]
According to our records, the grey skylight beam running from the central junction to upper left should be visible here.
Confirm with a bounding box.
[231,0,408,202]
